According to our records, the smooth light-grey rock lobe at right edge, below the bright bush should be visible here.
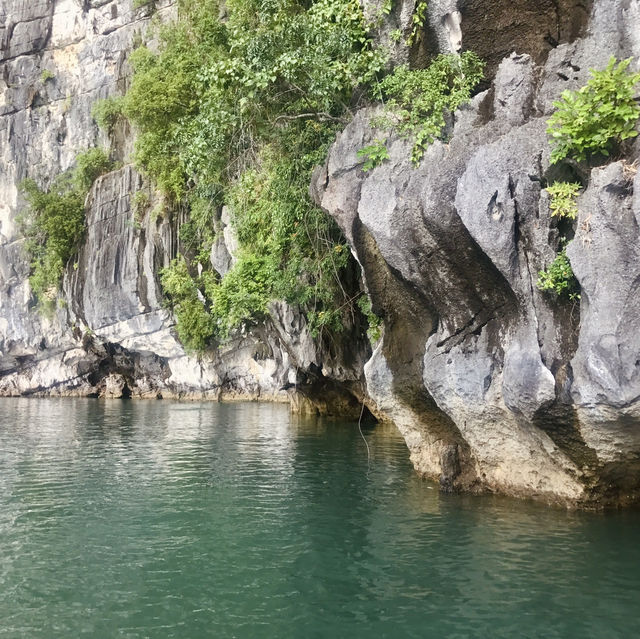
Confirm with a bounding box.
[567,162,640,461]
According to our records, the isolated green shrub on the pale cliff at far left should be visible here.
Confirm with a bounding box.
[21,149,112,310]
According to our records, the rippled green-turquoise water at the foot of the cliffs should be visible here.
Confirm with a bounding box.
[0,399,640,639]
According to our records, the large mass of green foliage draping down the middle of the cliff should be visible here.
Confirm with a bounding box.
[122,0,385,346]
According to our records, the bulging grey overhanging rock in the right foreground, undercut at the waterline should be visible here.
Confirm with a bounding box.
[312,0,640,504]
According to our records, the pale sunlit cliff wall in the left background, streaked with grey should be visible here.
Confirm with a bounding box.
[0,0,368,404]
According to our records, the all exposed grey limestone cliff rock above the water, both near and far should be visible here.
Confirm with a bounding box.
[0,0,640,505]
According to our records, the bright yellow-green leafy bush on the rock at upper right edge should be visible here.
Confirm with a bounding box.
[547,57,640,164]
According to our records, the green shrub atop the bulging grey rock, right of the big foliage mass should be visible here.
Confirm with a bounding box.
[377,51,484,164]
